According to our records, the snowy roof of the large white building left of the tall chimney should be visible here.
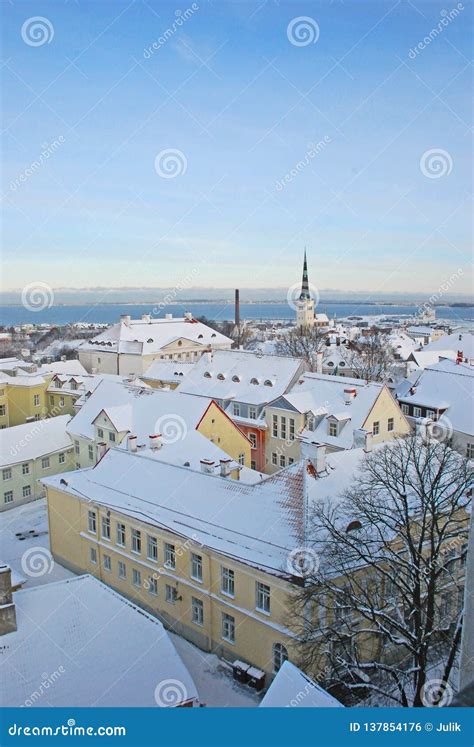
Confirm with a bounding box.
[81,315,232,355]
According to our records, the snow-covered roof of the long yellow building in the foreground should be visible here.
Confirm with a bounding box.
[43,449,364,575]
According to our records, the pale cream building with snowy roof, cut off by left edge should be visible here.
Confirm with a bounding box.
[0,415,74,511]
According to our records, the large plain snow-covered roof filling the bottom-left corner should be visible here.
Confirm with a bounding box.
[0,575,198,707]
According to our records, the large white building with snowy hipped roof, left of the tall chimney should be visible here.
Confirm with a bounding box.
[79,313,232,375]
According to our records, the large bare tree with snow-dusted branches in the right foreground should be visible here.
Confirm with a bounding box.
[291,435,473,706]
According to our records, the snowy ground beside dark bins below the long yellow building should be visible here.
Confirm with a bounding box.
[170,633,263,708]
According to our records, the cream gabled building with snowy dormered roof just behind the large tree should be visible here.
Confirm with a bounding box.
[265,373,410,473]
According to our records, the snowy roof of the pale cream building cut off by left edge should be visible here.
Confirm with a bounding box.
[0,415,72,467]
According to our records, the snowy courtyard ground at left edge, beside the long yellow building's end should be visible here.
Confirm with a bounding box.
[0,498,74,588]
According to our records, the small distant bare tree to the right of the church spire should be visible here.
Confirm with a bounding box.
[345,329,394,381]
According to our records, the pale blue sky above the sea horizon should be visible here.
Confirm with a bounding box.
[2,0,472,295]
